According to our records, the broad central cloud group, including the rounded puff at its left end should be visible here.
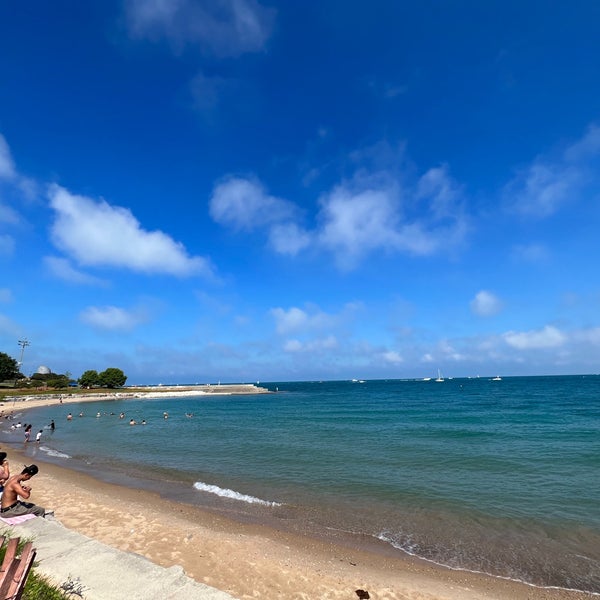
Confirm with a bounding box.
[210,153,468,270]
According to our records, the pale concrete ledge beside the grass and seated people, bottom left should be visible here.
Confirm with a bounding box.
[0,518,235,600]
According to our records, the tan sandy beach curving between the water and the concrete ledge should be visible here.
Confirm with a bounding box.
[3,392,593,600]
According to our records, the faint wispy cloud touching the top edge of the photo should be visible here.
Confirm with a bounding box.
[125,0,275,57]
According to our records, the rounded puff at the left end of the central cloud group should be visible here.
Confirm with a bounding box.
[210,177,296,231]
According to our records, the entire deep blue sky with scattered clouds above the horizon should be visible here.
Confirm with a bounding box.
[0,0,600,384]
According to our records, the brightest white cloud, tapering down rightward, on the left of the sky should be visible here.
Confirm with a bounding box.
[49,185,211,276]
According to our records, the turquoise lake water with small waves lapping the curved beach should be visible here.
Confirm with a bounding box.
[0,376,600,592]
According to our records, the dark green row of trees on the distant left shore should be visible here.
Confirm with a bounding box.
[0,352,127,388]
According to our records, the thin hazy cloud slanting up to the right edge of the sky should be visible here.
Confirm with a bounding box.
[504,125,600,218]
